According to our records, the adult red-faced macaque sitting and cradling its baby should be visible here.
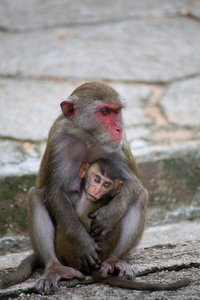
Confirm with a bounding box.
[0,82,190,294]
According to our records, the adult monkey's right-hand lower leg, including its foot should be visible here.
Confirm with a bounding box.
[100,189,148,279]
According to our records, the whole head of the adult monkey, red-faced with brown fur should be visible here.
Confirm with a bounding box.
[61,83,124,152]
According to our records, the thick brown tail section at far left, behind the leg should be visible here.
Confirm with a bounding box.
[0,253,39,289]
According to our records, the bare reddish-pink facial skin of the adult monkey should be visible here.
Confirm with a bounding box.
[95,103,123,145]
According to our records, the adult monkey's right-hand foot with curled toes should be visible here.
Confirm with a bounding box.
[100,258,135,280]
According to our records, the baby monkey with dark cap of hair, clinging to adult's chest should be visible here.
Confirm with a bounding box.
[75,158,124,234]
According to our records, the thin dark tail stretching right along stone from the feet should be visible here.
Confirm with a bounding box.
[95,275,191,291]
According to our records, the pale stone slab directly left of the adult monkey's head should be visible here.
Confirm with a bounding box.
[0,79,79,141]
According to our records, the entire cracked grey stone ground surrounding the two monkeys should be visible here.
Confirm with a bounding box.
[0,0,200,300]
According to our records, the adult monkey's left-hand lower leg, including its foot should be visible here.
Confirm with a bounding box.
[28,187,84,294]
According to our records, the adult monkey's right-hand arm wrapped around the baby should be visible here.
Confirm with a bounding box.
[90,144,148,240]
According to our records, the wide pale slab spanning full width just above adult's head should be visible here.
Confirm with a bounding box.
[0,17,200,82]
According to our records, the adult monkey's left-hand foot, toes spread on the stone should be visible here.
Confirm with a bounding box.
[36,263,85,295]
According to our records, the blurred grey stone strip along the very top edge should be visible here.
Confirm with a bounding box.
[0,0,194,30]
